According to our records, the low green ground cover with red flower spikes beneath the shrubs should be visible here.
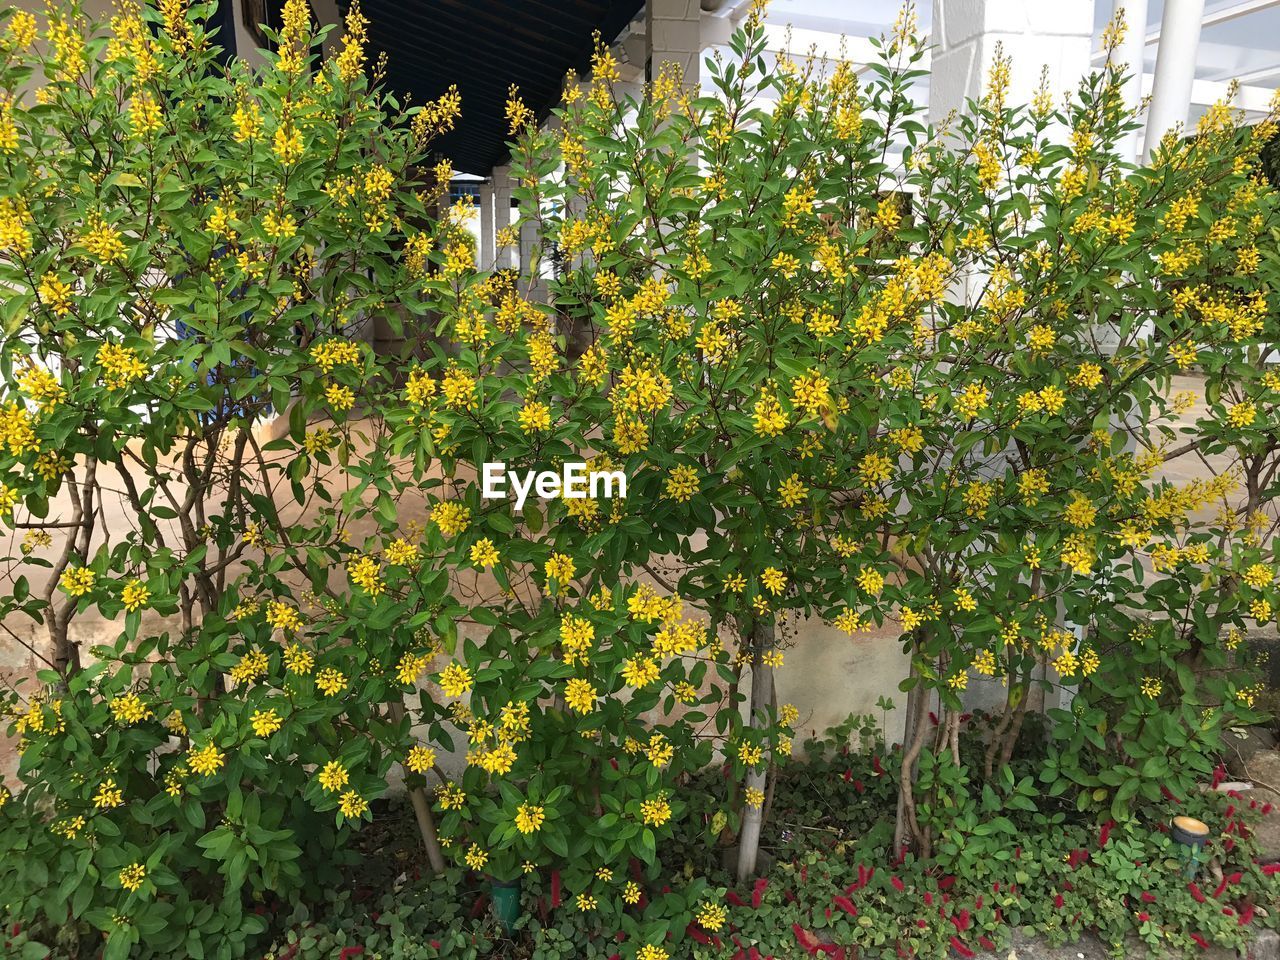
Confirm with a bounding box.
[240,721,1280,960]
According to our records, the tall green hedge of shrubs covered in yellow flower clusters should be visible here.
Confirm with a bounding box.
[0,0,1280,960]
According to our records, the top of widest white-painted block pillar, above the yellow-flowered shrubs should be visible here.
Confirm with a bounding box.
[929,0,1093,123]
